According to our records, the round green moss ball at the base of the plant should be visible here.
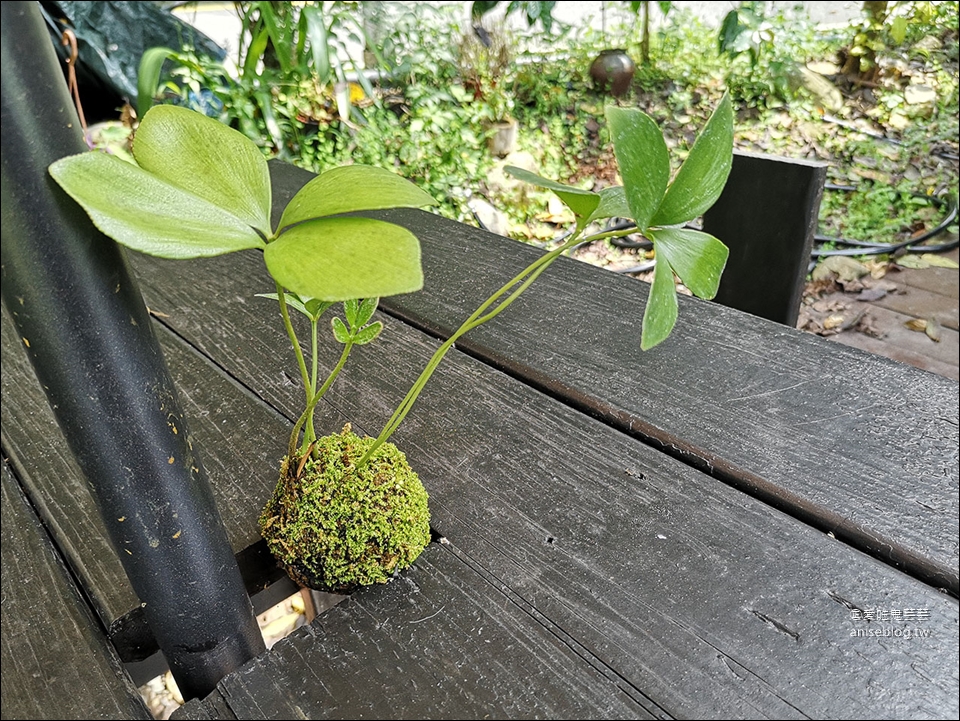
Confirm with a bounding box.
[260,424,430,593]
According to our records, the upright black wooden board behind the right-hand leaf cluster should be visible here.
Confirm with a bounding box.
[703,153,827,326]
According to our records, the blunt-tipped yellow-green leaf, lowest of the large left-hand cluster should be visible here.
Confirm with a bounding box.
[263,218,423,302]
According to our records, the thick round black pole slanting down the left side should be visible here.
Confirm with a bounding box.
[0,2,264,698]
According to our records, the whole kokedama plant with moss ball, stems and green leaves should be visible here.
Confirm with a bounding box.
[50,96,733,592]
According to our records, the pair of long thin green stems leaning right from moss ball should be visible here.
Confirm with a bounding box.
[356,228,592,468]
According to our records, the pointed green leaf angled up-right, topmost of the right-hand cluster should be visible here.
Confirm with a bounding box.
[651,94,733,225]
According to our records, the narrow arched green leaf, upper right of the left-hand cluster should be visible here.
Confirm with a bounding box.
[280,165,437,229]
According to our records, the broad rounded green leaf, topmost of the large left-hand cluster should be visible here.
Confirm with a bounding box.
[133,105,271,236]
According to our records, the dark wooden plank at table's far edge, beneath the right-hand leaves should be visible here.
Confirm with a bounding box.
[271,163,960,595]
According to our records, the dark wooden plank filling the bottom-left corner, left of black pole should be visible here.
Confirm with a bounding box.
[0,461,152,719]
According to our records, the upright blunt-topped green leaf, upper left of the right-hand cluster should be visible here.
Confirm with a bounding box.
[606,106,670,232]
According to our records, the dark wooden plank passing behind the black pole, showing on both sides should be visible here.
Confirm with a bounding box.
[2,300,300,661]
